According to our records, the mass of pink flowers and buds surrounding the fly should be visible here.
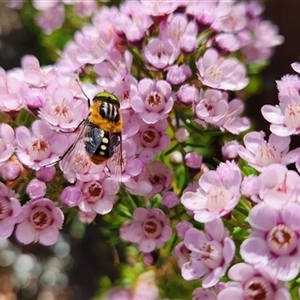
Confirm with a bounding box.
[0,0,290,300]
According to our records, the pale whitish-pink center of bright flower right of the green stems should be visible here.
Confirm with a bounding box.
[206,185,232,211]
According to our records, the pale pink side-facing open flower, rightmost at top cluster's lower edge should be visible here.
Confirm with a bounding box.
[196,48,249,91]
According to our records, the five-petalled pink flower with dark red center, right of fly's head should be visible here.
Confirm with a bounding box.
[130,78,174,124]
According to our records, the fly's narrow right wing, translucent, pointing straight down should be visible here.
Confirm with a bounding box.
[106,133,123,193]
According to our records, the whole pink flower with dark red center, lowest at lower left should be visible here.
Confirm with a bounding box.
[16,198,64,246]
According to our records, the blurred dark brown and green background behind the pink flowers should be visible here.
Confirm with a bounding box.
[0,0,300,300]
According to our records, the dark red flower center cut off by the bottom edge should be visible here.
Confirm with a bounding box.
[244,276,274,300]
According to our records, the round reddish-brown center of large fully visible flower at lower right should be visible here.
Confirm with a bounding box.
[267,224,298,255]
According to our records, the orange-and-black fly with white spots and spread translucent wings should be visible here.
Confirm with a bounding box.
[60,83,123,188]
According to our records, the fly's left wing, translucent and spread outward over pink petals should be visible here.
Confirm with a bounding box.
[59,122,91,183]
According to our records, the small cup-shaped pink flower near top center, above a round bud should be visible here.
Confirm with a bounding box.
[142,38,179,70]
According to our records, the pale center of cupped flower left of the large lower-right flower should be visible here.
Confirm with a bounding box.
[199,241,223,269]
